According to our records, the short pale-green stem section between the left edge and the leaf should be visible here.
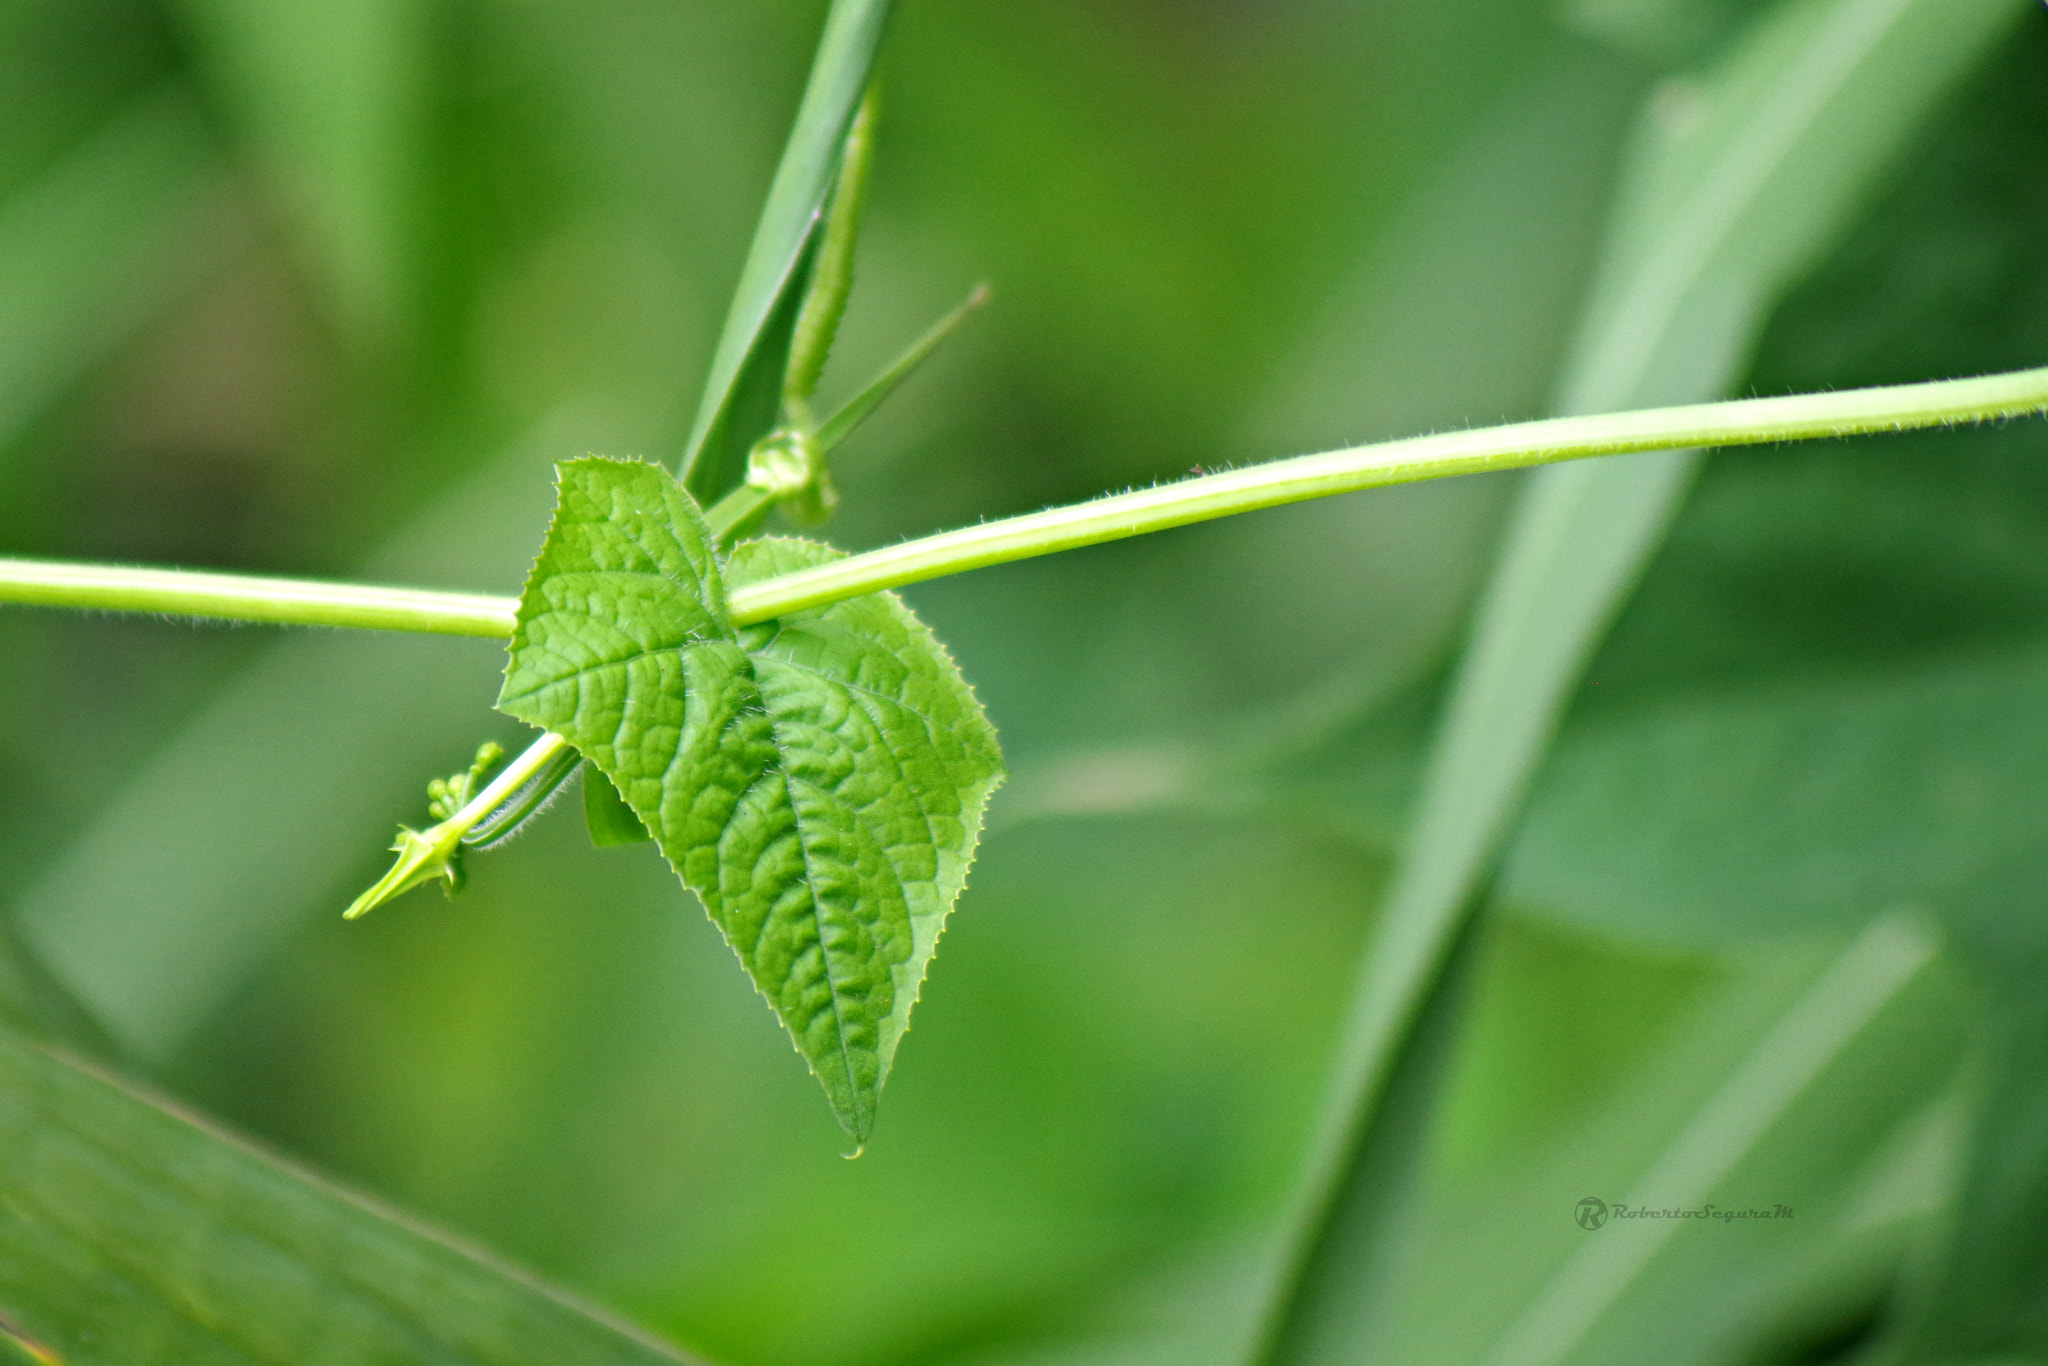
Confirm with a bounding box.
[0,559,518,637]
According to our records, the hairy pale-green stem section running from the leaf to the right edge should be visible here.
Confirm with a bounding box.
[731,367,2048,625]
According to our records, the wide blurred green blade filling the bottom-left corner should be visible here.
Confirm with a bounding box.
[0,1030,704,1366]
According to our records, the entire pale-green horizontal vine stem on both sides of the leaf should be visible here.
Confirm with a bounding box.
[0,367,2048,637]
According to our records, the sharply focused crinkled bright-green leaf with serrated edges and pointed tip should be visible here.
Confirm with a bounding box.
[500,459,1001,1143]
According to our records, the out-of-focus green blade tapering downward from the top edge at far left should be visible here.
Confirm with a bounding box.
[176,0,432,344]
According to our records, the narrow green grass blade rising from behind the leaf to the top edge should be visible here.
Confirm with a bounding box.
[680,0,889,508]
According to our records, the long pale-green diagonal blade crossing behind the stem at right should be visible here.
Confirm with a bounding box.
[1268,0,2025,1362]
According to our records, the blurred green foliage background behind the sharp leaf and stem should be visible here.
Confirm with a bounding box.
[12,0,2048,1366]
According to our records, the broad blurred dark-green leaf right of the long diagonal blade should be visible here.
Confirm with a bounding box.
[1503,647,2048,944]
